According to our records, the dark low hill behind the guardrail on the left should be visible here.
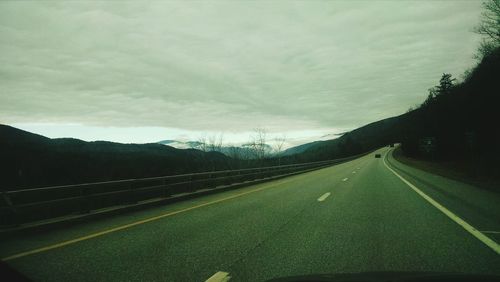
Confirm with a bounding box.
[0,125,231,189]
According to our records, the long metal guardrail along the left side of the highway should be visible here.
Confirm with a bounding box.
[0,153,366,227]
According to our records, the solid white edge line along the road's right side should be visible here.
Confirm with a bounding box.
[383,151,500,255]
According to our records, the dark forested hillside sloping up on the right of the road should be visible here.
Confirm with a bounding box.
[296,48,500,176]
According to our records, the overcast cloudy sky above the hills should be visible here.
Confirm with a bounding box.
[0,0,481,148]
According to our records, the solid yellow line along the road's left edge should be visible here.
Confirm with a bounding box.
[2,175,296,261]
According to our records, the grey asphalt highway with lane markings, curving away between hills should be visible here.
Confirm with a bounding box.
[0,148,500,281]
